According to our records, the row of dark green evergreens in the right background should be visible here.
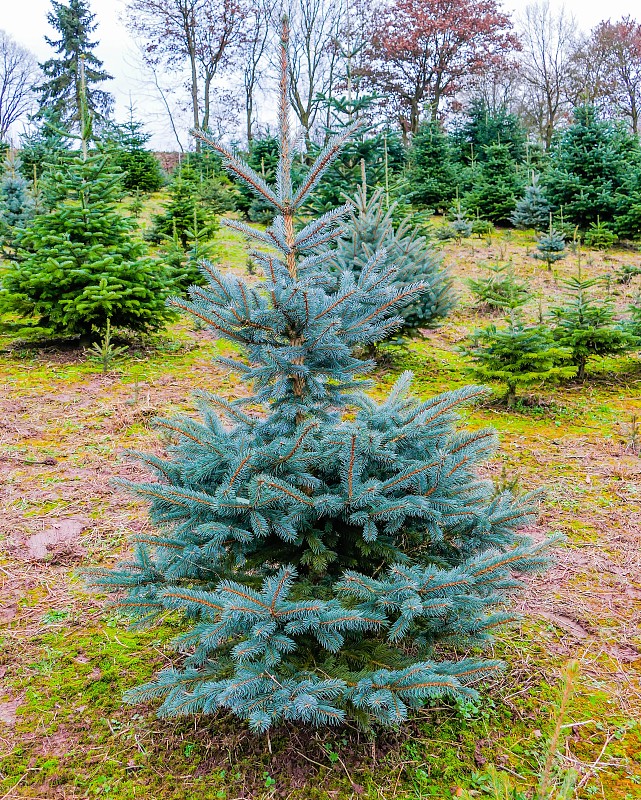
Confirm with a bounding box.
[406,101,641,239]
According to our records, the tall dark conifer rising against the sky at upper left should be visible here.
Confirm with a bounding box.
[36,0,113,127]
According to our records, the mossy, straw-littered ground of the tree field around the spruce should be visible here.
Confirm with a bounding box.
[0,216,641,800]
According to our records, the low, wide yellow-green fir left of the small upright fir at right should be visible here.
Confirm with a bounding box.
[465,314,574,407]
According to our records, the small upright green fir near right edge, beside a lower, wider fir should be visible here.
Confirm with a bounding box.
[550,269,638,380]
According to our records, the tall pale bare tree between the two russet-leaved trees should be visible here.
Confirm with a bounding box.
[520,0,577,150]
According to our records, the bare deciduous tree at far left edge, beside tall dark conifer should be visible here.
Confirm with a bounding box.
[0,31,39,139]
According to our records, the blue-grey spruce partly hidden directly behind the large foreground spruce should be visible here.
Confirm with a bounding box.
[332,185,454,334]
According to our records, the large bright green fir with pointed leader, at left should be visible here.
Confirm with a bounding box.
[2,64,171,337]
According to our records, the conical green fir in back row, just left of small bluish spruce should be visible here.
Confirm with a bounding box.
[463,144,523,223]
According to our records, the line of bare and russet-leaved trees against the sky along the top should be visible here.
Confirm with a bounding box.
[0,0,641,149]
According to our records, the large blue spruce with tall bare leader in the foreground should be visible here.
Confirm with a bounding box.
[92,24,547,731]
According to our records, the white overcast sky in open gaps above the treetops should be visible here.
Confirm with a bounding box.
[0,0,640,150]
